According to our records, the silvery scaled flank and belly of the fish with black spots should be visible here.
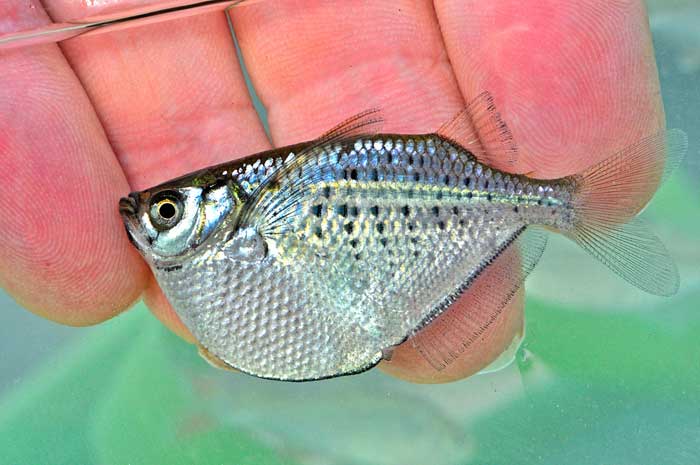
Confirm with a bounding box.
[157,132,565,379]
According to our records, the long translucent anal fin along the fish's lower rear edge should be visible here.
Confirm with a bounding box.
[410,227,547,371]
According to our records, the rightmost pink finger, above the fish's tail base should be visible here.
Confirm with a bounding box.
[435,0,663,178]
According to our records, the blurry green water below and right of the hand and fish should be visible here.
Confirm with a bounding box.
[0,1,700,465]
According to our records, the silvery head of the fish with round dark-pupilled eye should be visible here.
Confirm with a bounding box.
[119,178,241,267]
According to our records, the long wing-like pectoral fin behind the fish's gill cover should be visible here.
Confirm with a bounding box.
[239,109,384,237]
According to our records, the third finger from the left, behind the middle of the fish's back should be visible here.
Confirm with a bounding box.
[233,0,522,382]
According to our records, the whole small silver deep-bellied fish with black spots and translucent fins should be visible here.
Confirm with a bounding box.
[119,92,687,381]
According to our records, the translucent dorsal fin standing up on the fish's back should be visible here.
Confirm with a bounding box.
[437,91,518,169]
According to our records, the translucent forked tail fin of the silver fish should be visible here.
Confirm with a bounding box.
[563,129,688,296]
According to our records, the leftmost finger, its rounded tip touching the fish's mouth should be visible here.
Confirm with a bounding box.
[0,0,147,325]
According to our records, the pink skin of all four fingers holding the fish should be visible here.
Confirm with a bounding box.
[0,0,663,382]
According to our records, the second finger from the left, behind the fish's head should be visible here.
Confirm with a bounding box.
[41,0,269,339]
